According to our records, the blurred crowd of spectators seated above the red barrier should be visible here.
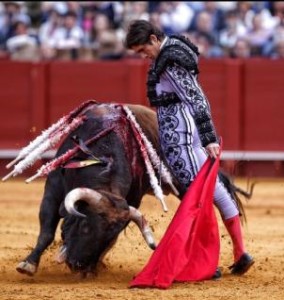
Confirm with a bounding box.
[0,1,284,61]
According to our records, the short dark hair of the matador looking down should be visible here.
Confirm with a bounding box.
[125,20,165,49]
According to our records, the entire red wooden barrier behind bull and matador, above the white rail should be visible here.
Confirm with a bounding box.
[0,58,284,174]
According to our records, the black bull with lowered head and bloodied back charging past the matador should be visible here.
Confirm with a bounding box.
[11,103,253,275]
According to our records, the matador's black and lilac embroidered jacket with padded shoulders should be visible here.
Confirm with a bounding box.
[147,35,218,147]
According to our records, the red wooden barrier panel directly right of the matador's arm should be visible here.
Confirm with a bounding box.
[199,59,243,150]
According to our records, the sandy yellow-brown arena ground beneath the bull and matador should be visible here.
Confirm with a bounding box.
[0,179,284,300]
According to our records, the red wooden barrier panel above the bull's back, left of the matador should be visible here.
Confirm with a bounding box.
[47,60,149,122]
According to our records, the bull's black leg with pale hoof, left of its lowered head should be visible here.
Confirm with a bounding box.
[16,174,62,276]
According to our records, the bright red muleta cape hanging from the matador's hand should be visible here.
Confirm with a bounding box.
[130,155,220,289]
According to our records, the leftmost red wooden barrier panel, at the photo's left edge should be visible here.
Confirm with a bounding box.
[0,61,46,148]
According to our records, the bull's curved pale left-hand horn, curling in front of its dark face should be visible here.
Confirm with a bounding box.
[64,188,102,217]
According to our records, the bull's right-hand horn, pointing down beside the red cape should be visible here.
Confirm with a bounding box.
[129,206,156,250]
